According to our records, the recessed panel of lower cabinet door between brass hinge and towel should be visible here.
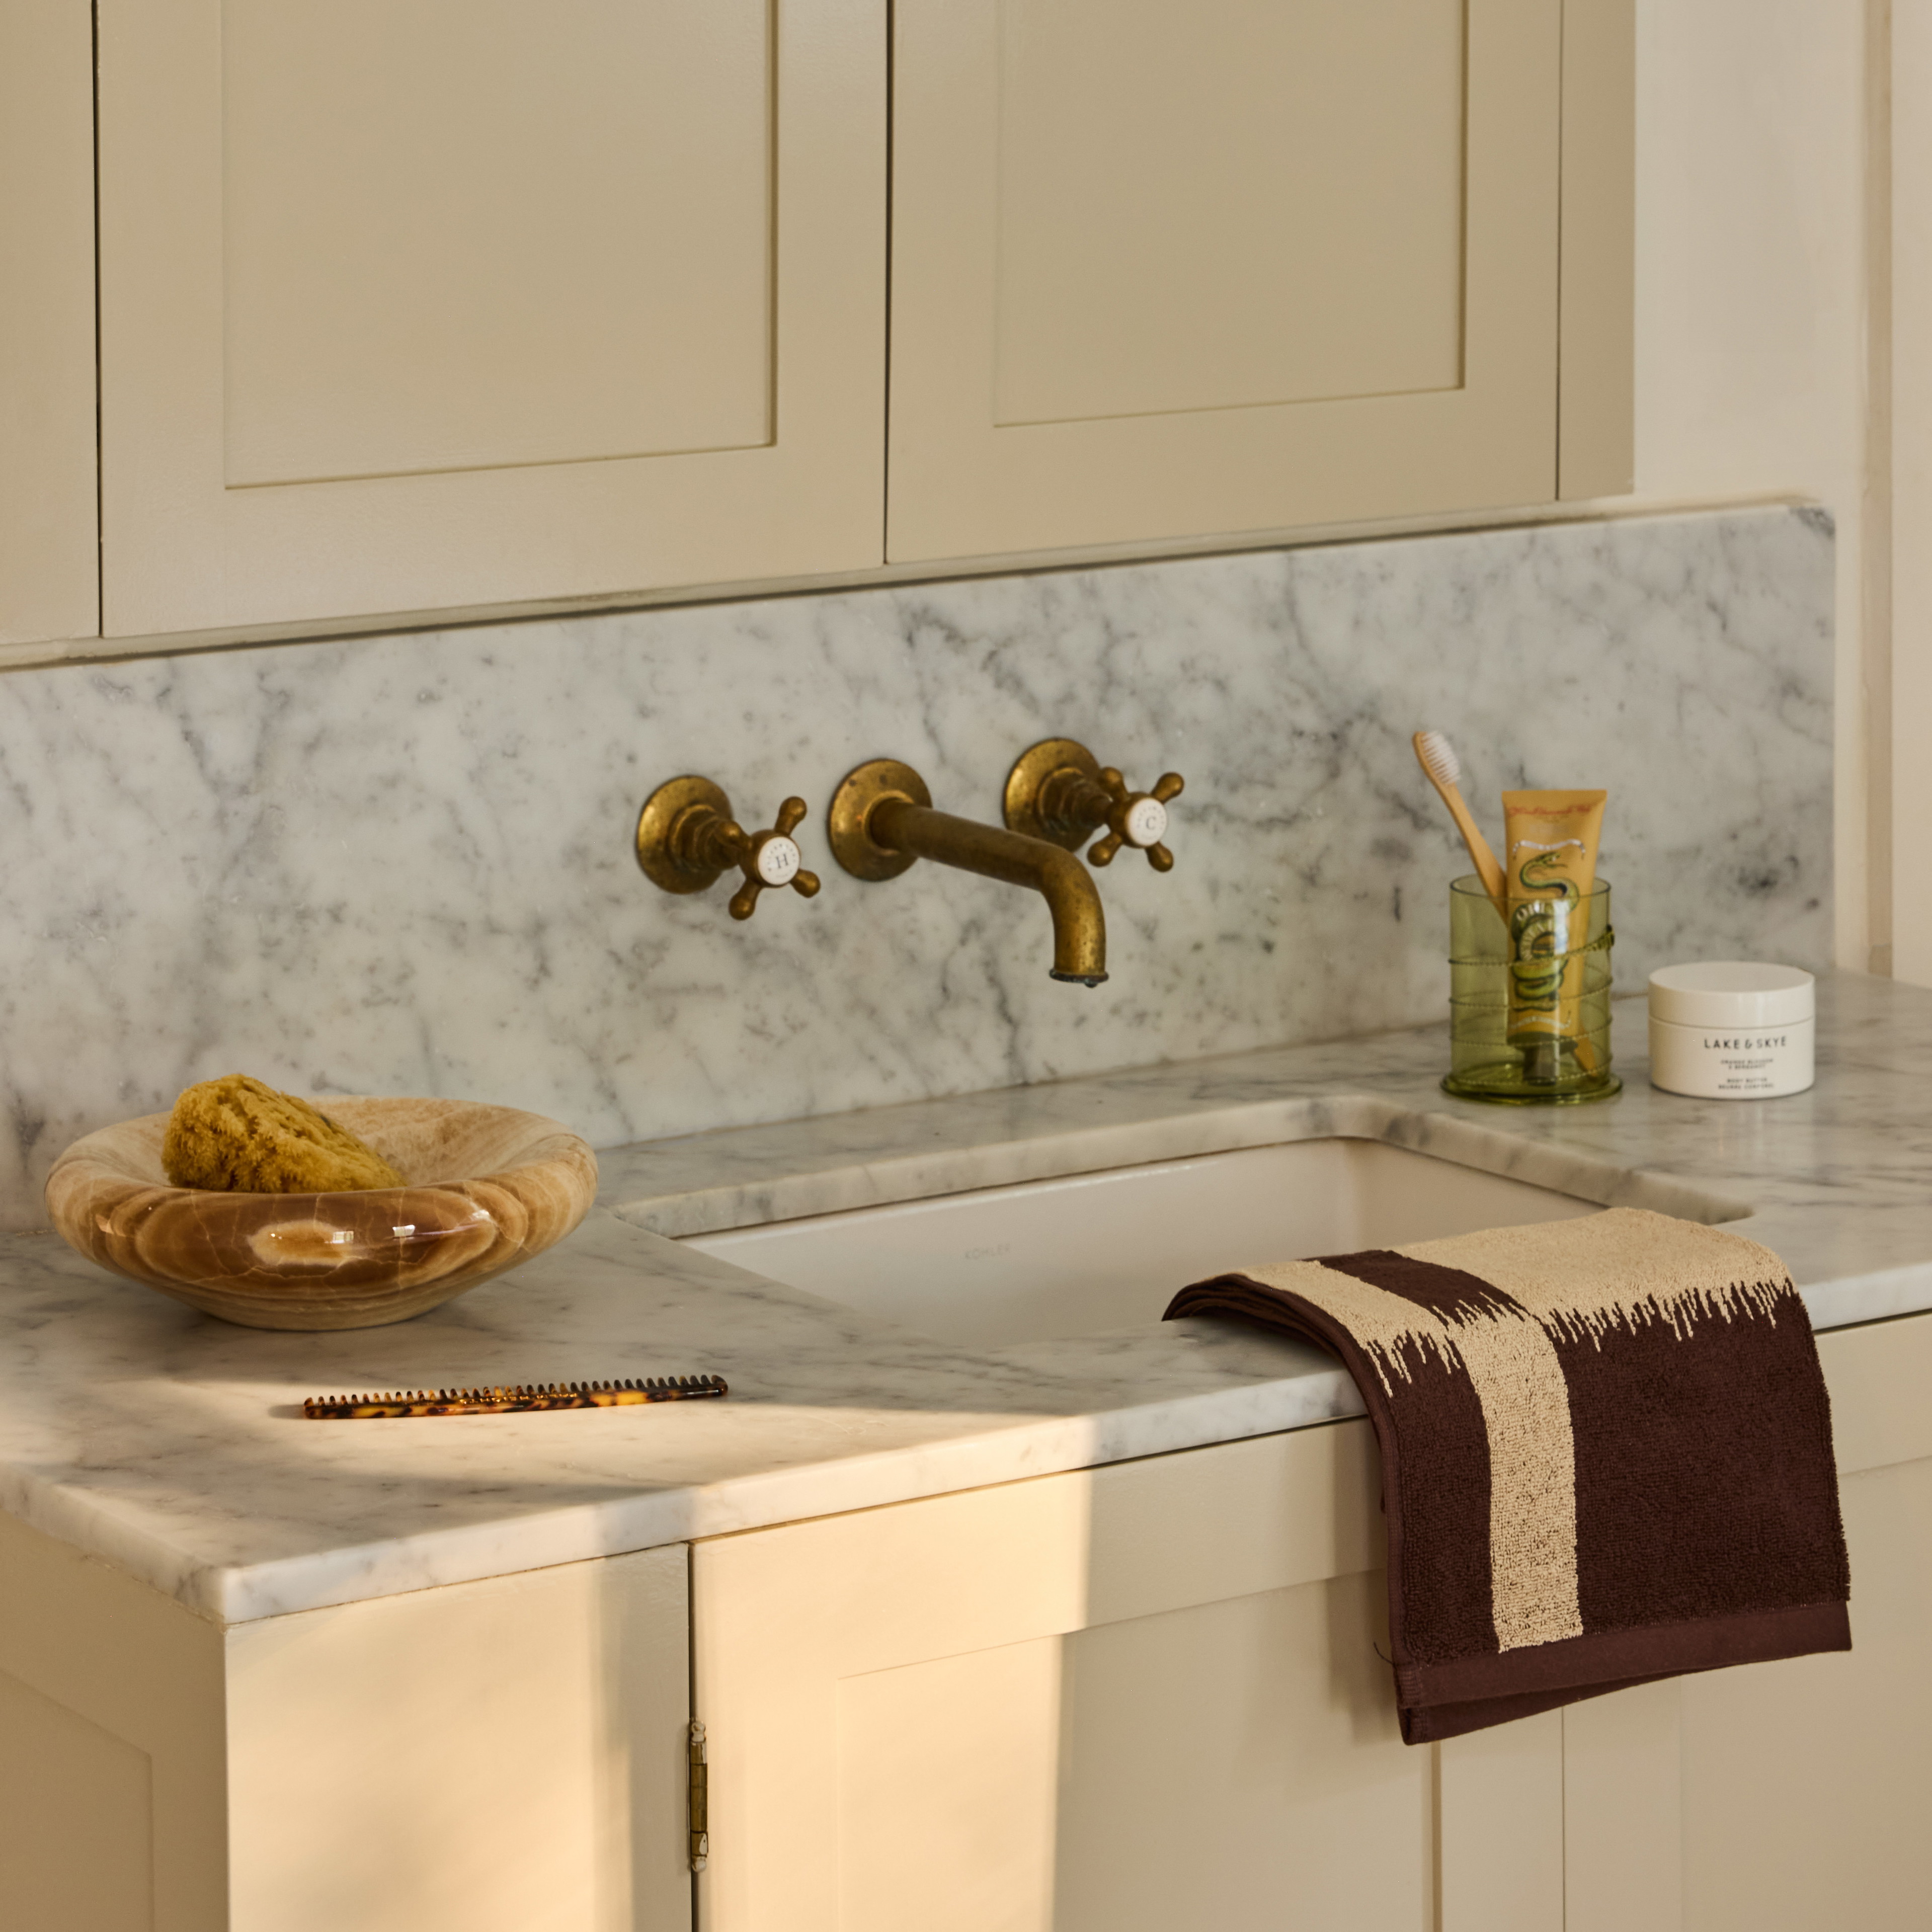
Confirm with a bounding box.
[839,1573,1433,1932]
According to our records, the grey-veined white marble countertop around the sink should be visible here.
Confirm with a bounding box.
[0,976,1932,1621]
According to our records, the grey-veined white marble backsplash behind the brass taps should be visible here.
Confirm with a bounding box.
[0,508,1831,1227]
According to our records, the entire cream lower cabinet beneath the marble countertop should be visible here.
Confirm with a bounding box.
[11,1316,1932,1932]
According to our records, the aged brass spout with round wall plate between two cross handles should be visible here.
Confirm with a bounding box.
[825,757,1107,985]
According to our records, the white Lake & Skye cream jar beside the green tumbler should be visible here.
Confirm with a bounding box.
[1650,960,1816,1099]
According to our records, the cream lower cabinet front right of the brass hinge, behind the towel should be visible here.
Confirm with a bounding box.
[692,1316,1932,1932]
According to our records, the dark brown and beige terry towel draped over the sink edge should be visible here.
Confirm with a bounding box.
[1167,1208,1851,1745]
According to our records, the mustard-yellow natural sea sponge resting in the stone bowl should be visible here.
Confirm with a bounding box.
[160,1074,404,1194]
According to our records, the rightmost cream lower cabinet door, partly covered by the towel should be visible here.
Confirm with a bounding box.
[1563,1316,1932,1932]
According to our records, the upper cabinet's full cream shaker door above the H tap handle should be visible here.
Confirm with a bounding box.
[101,0,885,635]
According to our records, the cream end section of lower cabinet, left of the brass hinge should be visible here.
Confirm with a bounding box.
[0,1516,692,1932]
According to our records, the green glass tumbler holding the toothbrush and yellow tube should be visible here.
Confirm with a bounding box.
[1443,875,1623,1107]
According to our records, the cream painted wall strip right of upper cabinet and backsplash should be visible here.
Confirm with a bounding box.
[1636,0,1870,970]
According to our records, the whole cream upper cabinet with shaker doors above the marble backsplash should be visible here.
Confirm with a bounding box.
[71,0,1635,641]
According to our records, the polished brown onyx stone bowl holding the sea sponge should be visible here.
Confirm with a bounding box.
[46,1095,597,1329]
